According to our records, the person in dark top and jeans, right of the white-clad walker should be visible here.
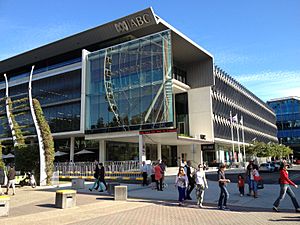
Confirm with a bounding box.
[218,164,230,210]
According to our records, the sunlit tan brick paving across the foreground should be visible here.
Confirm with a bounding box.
[0,188,300,225]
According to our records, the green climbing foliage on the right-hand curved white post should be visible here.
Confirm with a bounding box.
[33,99,55,185]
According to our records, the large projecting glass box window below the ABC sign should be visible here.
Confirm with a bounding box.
[85,31,173,133]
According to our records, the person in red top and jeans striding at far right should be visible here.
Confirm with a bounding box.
[273,163,300,212]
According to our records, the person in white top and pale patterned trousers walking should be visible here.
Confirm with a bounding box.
[195,164,208,208]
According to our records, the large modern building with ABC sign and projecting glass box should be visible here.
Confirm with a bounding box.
[0,8,277,166]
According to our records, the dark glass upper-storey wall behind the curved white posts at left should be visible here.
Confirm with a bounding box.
[0,67,81,137]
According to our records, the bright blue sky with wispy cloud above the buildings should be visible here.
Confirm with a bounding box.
[0,0,300,101]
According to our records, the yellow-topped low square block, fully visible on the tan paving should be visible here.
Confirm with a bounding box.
[55,190,76,209]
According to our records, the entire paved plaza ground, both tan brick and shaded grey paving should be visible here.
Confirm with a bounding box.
[0,166,300,225]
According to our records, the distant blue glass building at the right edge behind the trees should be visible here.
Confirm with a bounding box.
[268,97,300,159]
